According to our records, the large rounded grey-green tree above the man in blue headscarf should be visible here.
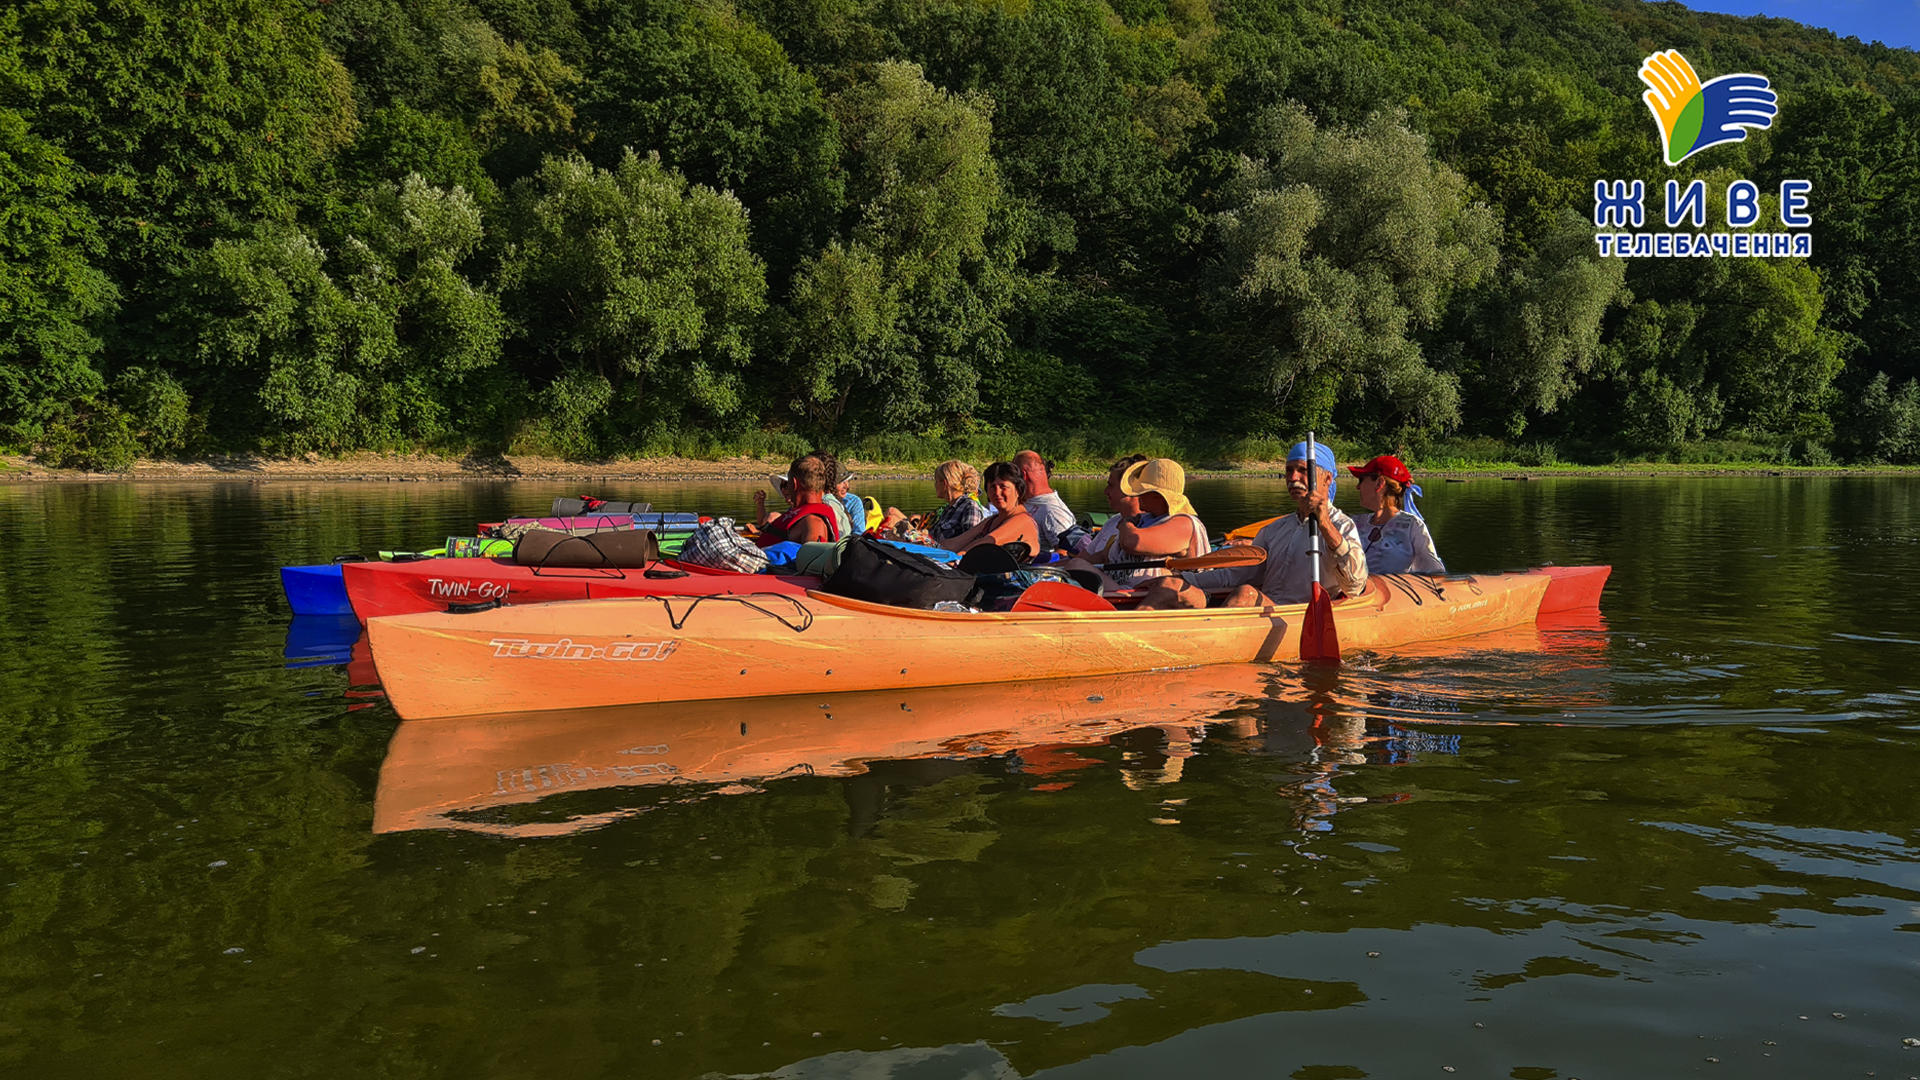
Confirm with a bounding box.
[1212,106,1498,438]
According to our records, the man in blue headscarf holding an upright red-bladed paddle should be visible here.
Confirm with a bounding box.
[1140,442,1367,607]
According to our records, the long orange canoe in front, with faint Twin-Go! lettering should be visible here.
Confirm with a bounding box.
[367,573,1551,721]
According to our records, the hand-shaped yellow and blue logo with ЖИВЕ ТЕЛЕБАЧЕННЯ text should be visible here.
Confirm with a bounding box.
[1594,48,1812,259]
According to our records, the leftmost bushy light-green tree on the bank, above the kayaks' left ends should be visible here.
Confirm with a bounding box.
[182,177,505,452]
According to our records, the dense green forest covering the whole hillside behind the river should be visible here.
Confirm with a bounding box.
[0,0,1920,467]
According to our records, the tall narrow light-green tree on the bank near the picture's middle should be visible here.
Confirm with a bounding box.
[772,61,1020,436]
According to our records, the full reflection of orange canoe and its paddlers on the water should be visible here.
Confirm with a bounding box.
[374,613,1605,838]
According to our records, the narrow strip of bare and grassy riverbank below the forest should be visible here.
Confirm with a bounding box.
[0,445,1920,482]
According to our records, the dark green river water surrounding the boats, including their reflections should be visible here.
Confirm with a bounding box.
[0,477,1920,1080]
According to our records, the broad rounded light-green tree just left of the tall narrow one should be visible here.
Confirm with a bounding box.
[499,150,766,440]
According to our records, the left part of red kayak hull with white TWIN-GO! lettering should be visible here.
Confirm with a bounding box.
[342,559,820,623]
